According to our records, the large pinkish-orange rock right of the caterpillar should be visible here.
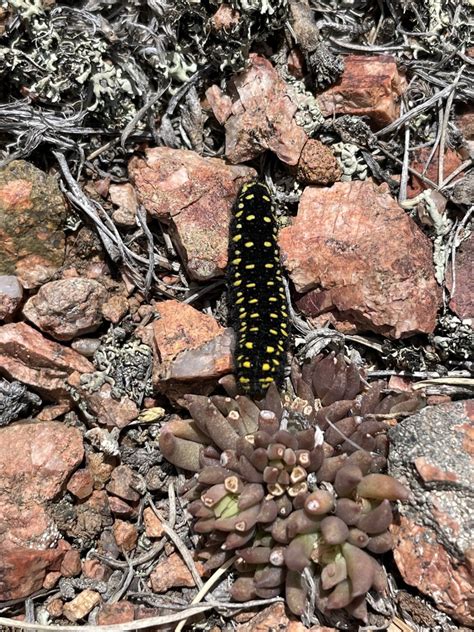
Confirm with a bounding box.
[280,179,441,338]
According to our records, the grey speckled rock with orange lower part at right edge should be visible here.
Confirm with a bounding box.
[389,401,474,626]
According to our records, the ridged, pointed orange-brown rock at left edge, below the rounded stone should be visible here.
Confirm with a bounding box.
[0,323,94,400]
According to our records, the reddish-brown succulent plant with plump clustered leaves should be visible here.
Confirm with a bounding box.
[160,354,420,621]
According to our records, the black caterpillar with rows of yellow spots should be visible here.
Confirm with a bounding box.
[228,182,288,396]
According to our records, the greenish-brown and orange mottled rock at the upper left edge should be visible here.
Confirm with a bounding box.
[0,160,66,288]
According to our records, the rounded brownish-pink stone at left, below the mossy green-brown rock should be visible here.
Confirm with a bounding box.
[23,278,107,340]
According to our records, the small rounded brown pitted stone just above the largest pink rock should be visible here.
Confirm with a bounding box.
[296,139,341,184]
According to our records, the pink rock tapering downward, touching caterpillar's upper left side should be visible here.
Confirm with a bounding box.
[129,147,255,281]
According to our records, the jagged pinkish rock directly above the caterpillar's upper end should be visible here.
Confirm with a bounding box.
[225,53,308,165]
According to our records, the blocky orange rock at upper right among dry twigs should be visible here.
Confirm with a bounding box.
[317,55,405,128]
